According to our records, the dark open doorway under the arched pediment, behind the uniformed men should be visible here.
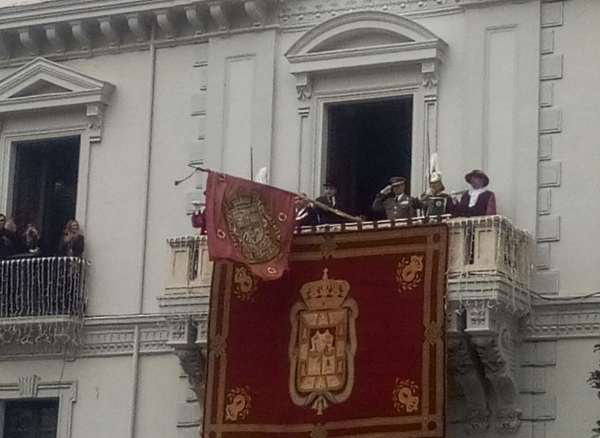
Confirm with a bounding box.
[326,96,413,220]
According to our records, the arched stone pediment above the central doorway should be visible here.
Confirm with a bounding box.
[285,11,447,74]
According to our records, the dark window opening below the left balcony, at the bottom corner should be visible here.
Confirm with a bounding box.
[4,399,58,438]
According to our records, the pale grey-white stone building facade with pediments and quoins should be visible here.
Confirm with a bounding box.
[0,0,600,438]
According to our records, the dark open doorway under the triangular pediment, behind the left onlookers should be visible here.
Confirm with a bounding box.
[12,137,80,255]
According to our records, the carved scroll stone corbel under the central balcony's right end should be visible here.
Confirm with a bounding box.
[465,301,523,433]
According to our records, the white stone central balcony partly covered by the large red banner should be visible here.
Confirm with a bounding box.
[159,216,532,434]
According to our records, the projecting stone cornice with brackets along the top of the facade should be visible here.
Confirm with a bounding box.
[0,0,524,66]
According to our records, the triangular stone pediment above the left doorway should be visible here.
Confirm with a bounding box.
[0,58,115,113]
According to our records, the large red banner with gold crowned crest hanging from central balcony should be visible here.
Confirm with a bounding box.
[204,225,448,438]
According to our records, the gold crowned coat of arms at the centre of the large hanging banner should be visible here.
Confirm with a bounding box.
[289,268,358,415]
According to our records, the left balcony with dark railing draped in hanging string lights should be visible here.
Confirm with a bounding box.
[0,257,90,345]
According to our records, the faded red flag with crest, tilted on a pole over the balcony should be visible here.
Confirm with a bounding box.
[205,171,297,280]
